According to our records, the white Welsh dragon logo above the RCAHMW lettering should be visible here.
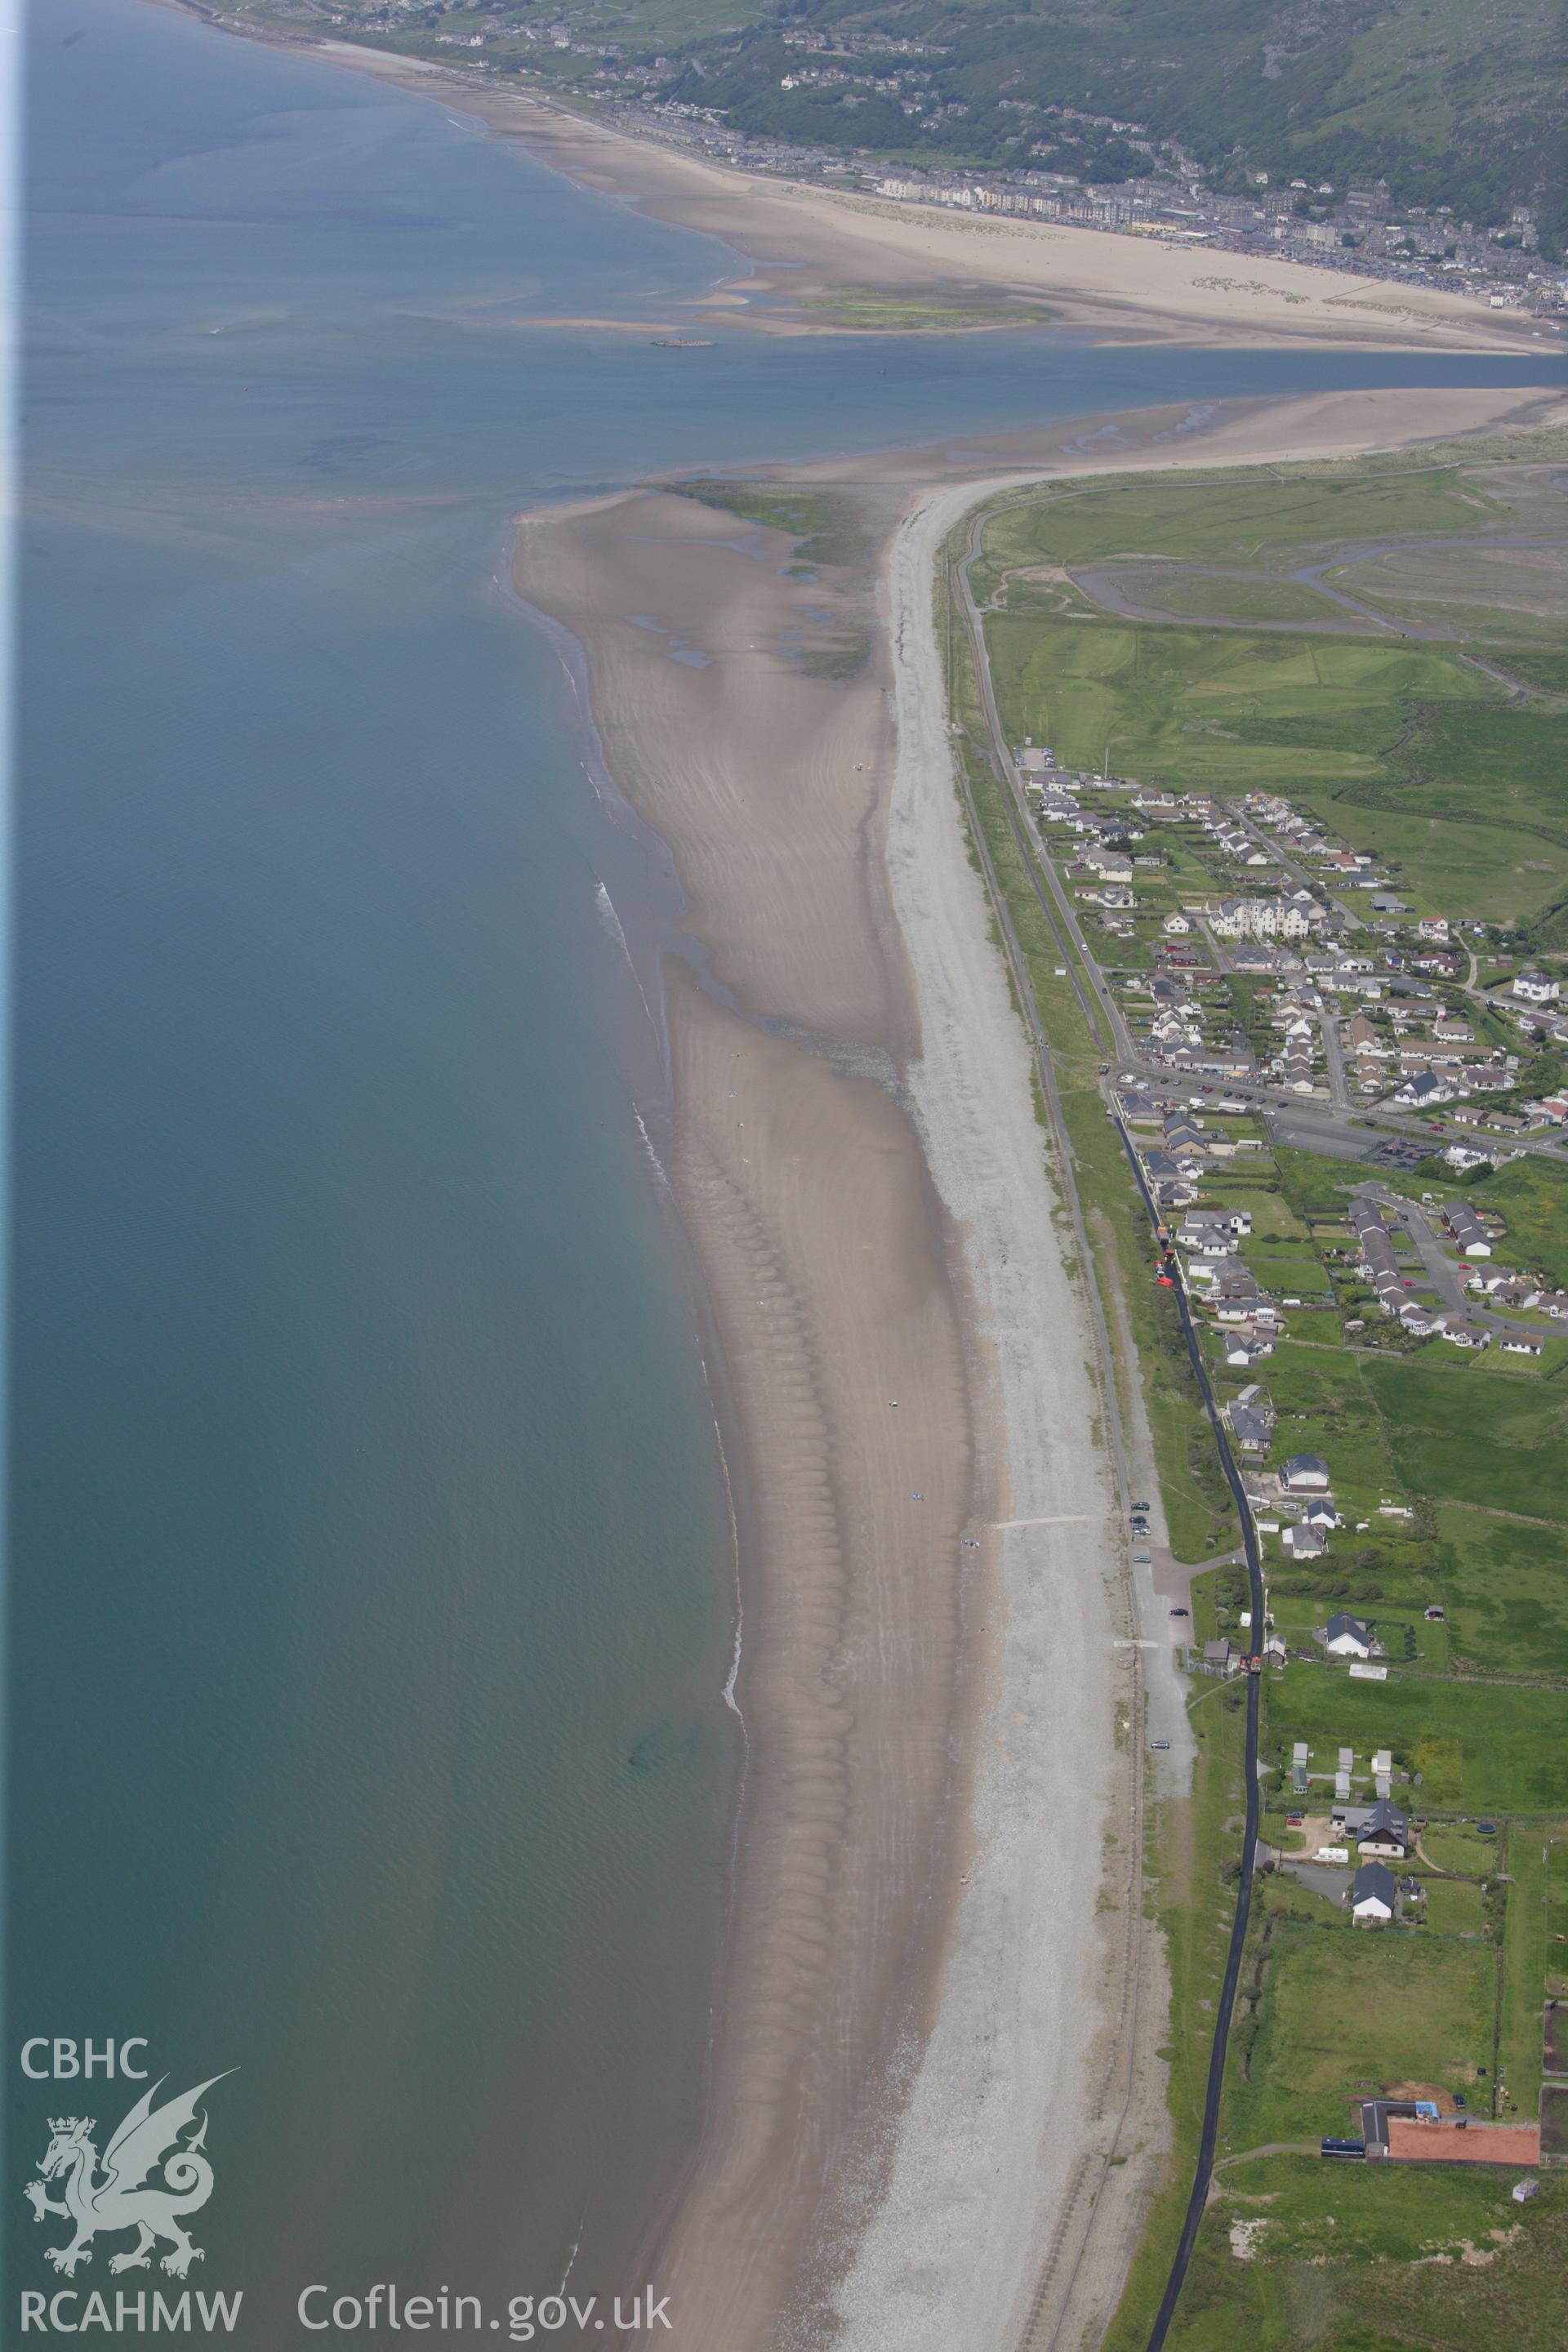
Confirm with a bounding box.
[24,2069,233,2279]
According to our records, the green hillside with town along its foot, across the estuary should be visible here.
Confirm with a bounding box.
[252,0,1568,254]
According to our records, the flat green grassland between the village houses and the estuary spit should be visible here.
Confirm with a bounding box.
[973,461,1568,938]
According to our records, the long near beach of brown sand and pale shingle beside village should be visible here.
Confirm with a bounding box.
[517,376,1539,2352]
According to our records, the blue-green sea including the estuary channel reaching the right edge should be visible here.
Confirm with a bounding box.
[0,0,1561,2323]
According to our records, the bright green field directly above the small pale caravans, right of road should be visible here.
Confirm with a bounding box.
[1267,1665,1568,1813]
